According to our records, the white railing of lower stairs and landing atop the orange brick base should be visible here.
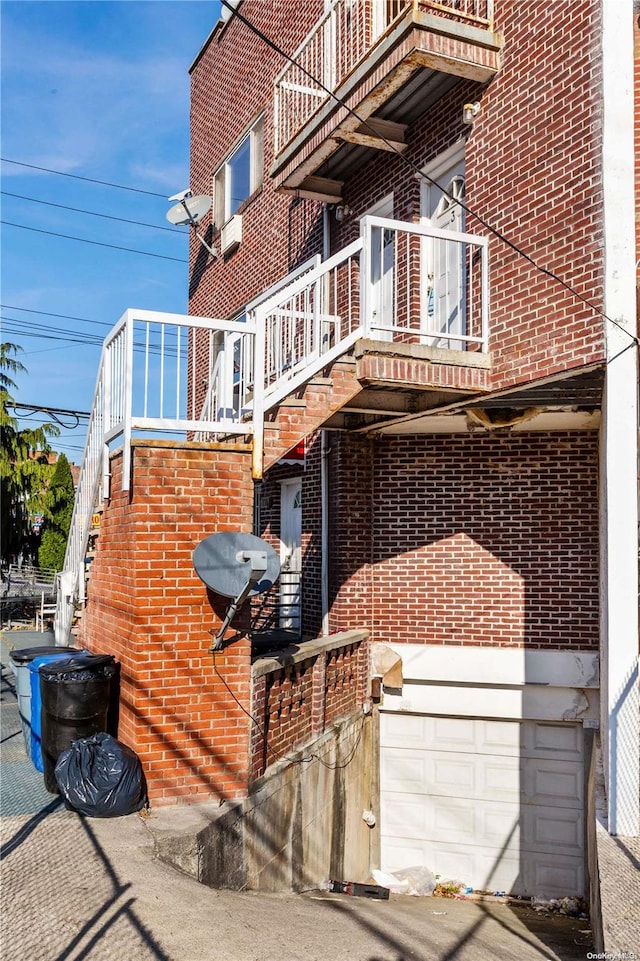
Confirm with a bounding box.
[55,310,253,644]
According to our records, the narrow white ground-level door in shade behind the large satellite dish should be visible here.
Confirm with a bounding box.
[278,478,302,633]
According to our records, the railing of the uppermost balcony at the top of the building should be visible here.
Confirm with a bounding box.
[274,0,493,156]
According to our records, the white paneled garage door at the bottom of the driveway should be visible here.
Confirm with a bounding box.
[380,713,584,897]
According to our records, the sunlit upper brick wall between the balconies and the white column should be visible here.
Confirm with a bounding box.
[467,0,603,387]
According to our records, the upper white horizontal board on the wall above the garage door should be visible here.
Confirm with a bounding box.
[376,644,600,689]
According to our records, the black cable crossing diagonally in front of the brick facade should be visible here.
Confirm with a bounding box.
[220,0,640,345]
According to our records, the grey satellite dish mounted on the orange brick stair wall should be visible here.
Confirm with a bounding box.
[193,531,280,651]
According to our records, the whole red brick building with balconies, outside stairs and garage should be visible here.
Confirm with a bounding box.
[67,0,639,894]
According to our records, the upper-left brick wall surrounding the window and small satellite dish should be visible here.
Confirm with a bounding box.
[189,0,323,317]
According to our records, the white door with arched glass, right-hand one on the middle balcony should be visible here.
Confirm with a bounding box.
[422,155,466,350]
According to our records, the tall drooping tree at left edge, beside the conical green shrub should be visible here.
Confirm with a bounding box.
[0,343,60,563]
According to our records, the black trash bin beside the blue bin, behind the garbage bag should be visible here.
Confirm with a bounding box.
[39,654,117,794]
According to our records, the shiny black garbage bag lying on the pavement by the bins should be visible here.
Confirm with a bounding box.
[55,734,147,818]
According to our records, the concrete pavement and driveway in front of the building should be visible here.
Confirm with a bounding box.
[0,632,596,961]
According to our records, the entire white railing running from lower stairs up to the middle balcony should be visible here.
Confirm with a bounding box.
[56,216,489,643]
